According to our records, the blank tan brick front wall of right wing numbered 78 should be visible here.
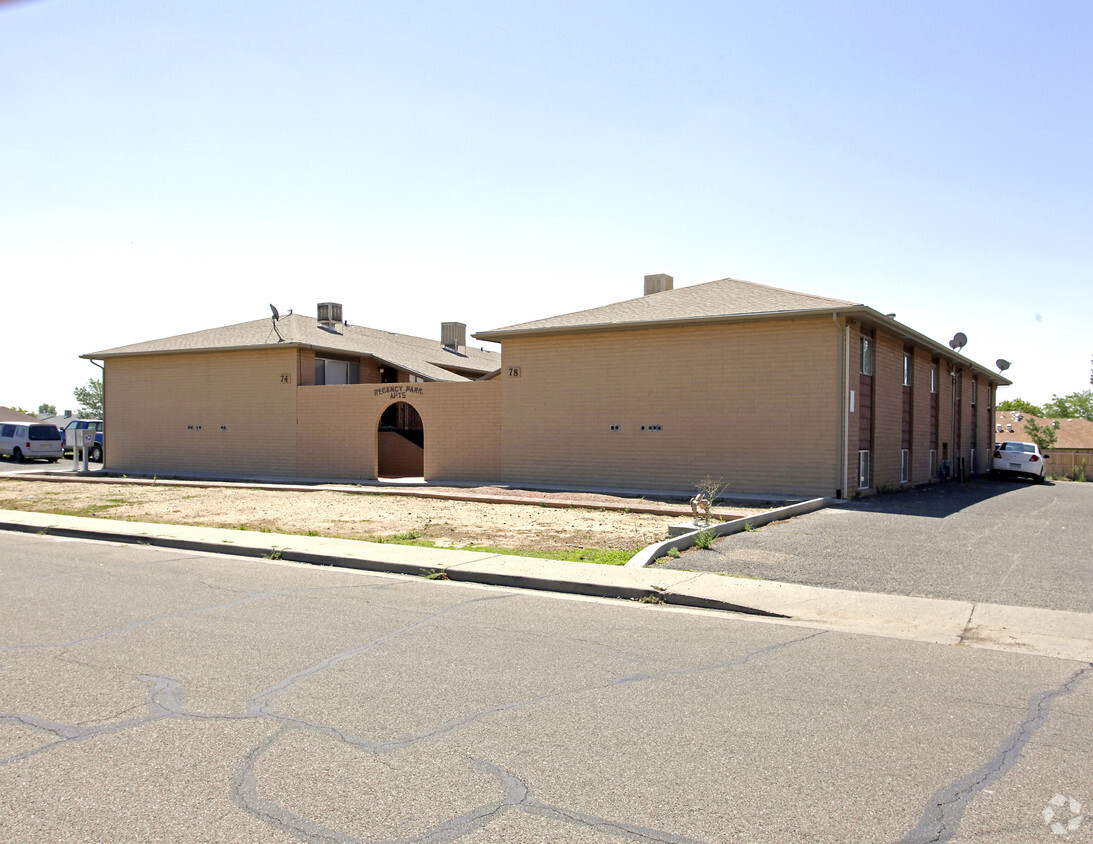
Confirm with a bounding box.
[501,317,842,495]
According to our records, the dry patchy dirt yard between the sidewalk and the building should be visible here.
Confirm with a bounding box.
[0,479,757,551]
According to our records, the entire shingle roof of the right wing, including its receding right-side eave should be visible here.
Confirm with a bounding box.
[474,279,1010,384]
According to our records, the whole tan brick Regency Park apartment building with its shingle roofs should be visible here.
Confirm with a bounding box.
[84,276,1009,496]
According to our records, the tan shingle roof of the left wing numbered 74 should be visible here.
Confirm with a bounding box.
[81,314,501,382]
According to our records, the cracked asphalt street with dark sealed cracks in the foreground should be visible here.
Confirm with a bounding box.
[0,532,1093,844]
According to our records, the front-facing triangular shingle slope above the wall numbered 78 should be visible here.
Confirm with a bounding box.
[474,279,855,340]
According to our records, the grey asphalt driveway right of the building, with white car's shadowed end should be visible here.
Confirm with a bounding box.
[662,480,1093,612]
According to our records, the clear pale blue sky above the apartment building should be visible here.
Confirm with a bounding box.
[0,0,1093,410]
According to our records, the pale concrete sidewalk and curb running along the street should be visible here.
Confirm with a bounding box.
[0,511,1093,661]
